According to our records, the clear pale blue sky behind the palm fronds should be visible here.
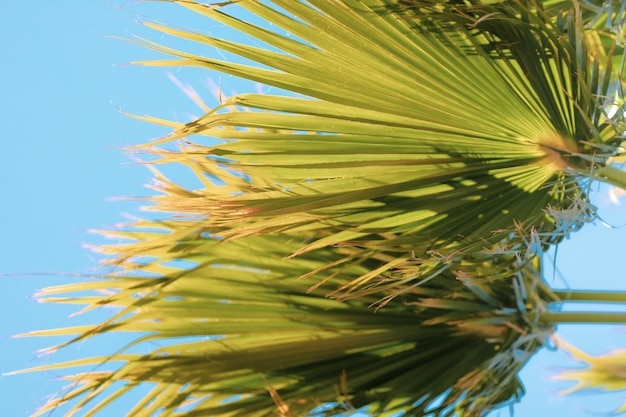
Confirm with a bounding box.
[0,0,626,417]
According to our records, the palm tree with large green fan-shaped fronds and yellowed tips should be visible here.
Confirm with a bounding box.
[8,0,626,416]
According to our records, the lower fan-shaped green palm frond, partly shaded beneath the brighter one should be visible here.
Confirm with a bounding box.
[13,221,555,417]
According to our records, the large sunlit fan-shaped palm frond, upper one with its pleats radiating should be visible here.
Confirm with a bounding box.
[114,0,626,296]
